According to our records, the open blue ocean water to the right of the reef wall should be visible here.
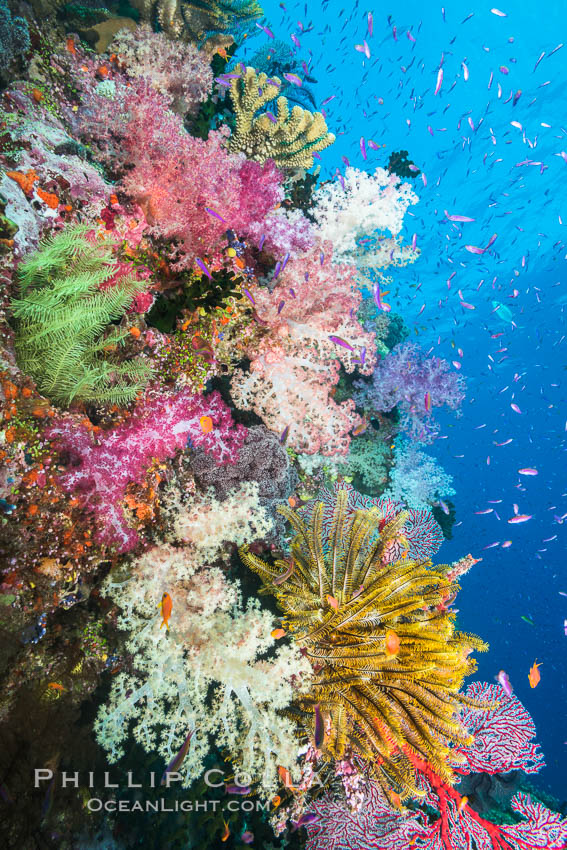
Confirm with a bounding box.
[245,0,567,800]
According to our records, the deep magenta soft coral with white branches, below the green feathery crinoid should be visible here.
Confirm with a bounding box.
[45,389,246,552]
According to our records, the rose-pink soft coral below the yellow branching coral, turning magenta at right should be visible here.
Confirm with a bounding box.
[117,81,283,268]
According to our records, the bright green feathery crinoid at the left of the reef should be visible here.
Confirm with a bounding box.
[11,226,152,406]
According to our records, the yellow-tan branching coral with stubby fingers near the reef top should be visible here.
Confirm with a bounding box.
[229,68,335,168]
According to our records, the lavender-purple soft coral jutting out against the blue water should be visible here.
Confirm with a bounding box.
[354,342,465,443]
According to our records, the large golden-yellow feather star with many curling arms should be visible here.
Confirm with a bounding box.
[240,491,494,805]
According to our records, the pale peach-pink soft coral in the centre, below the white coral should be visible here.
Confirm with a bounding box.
[231,244,376,455]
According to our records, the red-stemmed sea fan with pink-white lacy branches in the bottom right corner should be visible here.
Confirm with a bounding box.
[307,682,567,850]
